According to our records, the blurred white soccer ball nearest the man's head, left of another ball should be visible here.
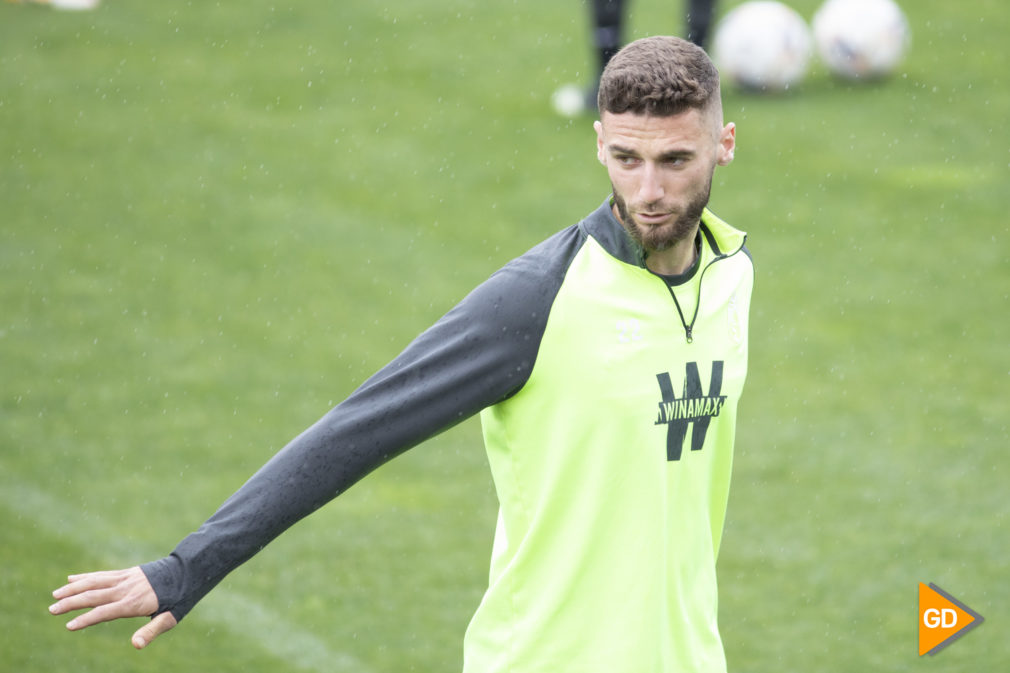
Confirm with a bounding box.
[712,0,813,91]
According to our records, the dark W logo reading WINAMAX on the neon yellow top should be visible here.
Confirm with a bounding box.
[655,360,726,461]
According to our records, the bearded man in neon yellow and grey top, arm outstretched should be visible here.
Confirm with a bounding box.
[51,37,753,673]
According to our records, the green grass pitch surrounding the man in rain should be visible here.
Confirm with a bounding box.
[0,0,1010,673]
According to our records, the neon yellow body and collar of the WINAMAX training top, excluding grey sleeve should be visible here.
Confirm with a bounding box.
[464,200,753,673]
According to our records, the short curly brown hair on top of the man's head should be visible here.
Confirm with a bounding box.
[597,36,719,116]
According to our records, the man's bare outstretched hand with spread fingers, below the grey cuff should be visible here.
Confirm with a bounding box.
[49,567,177,650]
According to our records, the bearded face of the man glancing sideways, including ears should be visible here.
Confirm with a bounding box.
[594,108,736,252]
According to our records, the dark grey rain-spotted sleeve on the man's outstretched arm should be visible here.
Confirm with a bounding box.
[141,227,582,619]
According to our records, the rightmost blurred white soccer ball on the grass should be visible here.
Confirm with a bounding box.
[813,0,911,80]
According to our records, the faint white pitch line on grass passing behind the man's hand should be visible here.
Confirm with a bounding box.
[0,479,369,673]
